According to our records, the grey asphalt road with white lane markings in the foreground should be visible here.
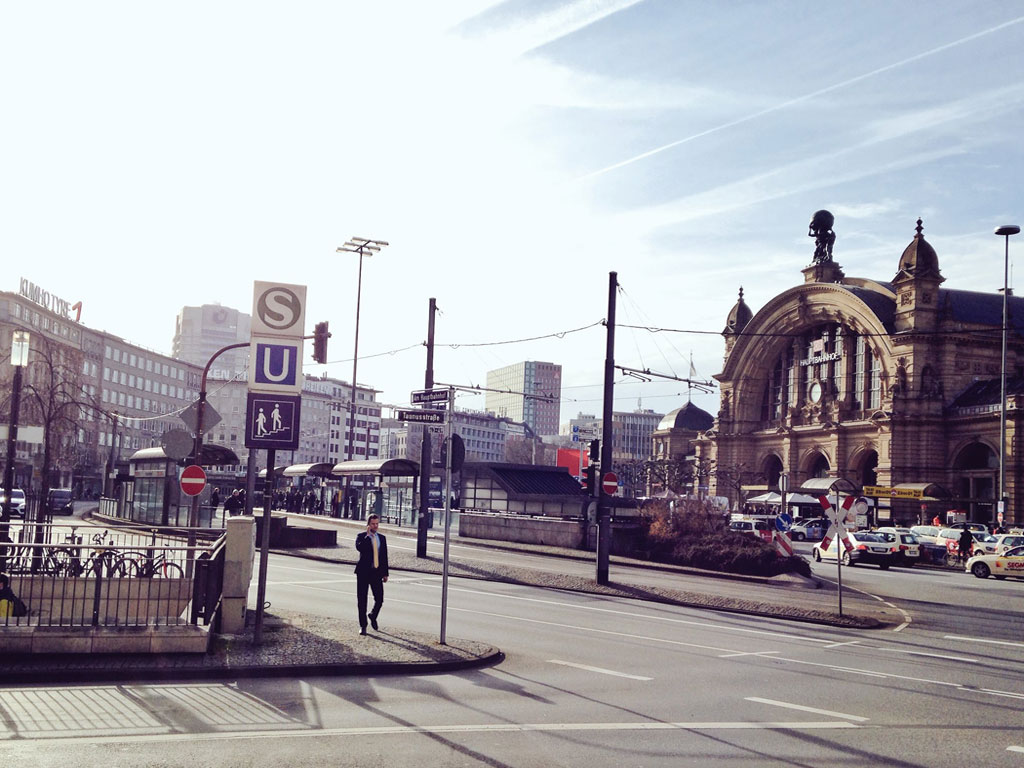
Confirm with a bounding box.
[0,556,1024,768]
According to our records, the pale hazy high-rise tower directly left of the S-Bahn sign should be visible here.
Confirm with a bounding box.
[171,304,252,378]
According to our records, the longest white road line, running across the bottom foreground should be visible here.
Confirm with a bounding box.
[0,721,863,752]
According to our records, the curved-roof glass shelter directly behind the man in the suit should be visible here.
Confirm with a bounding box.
[331,459,420,525]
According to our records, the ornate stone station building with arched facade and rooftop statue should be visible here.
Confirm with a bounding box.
[697,211,1024,524]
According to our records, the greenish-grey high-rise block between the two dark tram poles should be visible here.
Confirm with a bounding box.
[484,360,562,435]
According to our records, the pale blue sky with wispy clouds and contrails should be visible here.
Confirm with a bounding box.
[0,0,1024,428]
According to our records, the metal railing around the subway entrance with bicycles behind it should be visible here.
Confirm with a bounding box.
[0,523,224,632]
